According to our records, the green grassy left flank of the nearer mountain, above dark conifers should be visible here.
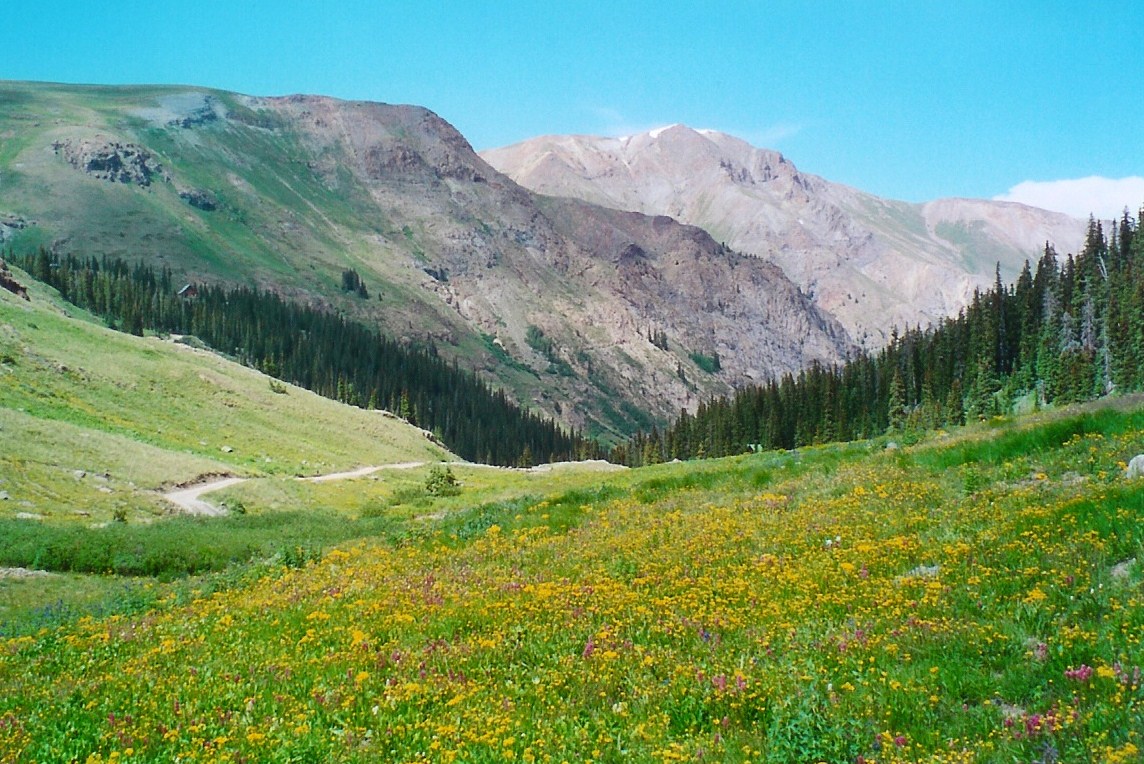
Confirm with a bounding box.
[0,82,553,434]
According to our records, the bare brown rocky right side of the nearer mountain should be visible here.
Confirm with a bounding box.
[255,98,850,425]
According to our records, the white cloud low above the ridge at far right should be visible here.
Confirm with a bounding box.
[993,175,1144,220]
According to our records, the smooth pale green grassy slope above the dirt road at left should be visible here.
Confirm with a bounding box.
[0,263,452,523]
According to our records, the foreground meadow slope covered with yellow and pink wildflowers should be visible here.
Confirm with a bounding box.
[0,399,1144,762]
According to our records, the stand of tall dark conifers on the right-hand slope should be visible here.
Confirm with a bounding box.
[612,212,1144,465]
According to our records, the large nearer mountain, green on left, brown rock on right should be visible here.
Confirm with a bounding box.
[0,83,852,437]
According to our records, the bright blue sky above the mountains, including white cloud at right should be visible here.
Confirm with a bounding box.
[8,0,1144,215]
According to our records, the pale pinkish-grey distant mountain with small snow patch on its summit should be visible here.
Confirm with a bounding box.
[483,125,1085,347]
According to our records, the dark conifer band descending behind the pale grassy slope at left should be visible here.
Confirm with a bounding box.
[8,248,598,465]
